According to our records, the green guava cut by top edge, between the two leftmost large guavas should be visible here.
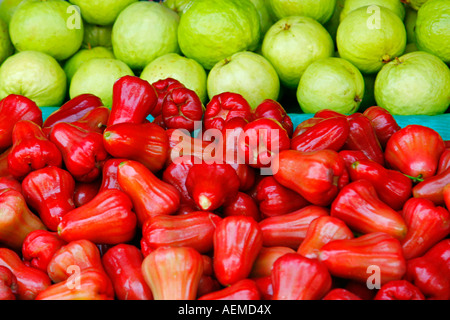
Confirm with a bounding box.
[69,0,138,26]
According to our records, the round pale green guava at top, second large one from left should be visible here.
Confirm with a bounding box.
[112,1,179,70]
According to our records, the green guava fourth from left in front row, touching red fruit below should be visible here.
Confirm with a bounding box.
[207,51,280,109]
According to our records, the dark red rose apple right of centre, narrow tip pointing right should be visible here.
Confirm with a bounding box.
[255,176,309,218]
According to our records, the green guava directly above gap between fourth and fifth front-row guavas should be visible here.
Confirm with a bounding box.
[261,16,334,89]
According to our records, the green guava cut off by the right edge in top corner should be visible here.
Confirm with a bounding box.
[415,0,450,63]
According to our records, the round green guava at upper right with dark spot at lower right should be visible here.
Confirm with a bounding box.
[336,6,406,74]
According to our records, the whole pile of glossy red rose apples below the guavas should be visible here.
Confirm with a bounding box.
[0,76,450,300]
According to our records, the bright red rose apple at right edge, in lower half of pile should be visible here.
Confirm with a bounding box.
[402,198,450,259]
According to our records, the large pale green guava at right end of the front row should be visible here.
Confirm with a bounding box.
[375,51,450,115]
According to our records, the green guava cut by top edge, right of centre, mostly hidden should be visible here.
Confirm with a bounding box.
[269,0,336,24]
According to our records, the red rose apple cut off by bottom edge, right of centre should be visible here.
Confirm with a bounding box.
[271,253,332,300]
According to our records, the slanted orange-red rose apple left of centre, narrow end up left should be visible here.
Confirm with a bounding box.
[117,160,180,226]
